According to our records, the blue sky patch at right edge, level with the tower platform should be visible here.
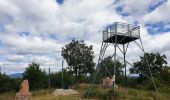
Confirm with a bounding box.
[145,21,170,35]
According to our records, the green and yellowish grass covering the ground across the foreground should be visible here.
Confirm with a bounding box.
[0,84,170,100]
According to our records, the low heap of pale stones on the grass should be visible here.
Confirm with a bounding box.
[53,89,79,96]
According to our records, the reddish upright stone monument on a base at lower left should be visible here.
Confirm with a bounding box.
[15,80,32,100]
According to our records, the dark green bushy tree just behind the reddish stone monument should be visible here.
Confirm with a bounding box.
[23,62,47,89]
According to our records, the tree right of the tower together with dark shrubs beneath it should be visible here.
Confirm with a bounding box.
[130,53,170,90]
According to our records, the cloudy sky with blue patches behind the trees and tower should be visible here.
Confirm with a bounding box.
[0,0,170,74]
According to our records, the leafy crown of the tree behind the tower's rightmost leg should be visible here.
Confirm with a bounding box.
[130,53,167,80]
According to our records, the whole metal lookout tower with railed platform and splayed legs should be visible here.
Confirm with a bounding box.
[88,22,157,96]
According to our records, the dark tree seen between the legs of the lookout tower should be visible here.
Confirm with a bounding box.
[98,56,123,77]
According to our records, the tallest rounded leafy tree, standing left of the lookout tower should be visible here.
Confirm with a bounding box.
[62,39,95,77]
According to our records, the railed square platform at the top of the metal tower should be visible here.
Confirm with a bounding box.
[103,22,140,44]
